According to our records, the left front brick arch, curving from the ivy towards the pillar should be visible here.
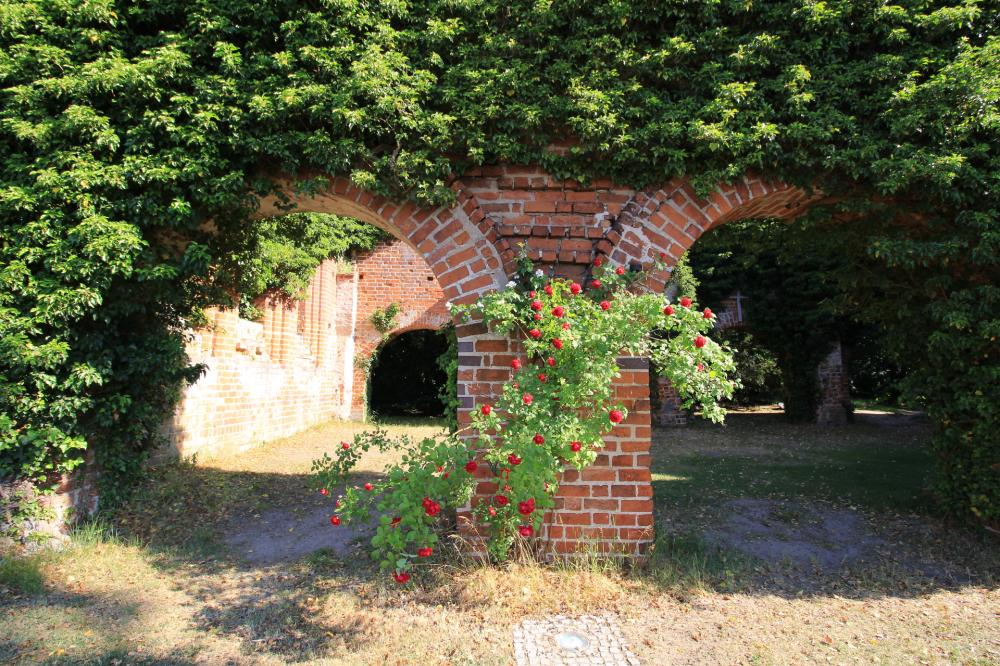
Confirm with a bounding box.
[258,177,507,304]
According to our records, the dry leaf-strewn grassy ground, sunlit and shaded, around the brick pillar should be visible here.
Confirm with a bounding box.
[0,410,1000,665]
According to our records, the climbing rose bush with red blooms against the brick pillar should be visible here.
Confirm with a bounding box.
[314,258,736,583]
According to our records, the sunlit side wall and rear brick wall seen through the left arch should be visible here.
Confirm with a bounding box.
[166,240,449,457]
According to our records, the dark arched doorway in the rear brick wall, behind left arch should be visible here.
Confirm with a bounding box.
[368,329,448,417]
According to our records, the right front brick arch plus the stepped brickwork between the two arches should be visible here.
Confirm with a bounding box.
[446,165,813,291]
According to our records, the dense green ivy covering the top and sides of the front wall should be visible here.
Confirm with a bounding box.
[0,0,1000,520]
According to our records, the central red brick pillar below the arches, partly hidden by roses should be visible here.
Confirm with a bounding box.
[458,326,653,555]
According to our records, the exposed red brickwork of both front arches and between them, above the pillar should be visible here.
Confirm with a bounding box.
[259,165,817,303]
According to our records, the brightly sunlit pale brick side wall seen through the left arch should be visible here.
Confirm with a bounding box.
[167,262,354,456]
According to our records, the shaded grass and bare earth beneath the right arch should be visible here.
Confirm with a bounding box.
[652,412,1000,597]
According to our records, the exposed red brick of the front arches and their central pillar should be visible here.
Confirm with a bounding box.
[246,165,814,554]
